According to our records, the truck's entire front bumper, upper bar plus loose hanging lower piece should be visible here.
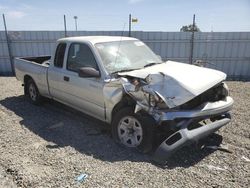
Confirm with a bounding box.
[153,97,233,165]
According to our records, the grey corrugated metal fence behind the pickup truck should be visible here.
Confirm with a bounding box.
[0,31,250,80]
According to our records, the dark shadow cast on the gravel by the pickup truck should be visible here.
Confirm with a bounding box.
[0,96,222,168]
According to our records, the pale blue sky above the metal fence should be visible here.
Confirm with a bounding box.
[0,0,250,32]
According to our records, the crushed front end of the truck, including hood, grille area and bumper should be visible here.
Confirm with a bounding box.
[114,62,233,164]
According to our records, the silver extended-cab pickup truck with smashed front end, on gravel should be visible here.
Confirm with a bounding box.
[15,36,233,164]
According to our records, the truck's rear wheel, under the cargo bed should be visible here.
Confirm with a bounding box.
[26,79,42,105]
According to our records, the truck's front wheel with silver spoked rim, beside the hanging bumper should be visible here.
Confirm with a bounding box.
[112,107,155,153]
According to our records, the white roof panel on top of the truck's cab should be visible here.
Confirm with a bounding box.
[58,36,138,45]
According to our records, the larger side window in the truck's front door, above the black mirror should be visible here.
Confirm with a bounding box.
[67,43,98,72]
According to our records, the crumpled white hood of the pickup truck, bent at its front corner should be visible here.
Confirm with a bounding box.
[118,61,226,108]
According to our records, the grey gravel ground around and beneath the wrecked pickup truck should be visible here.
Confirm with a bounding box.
[0,77,250,187]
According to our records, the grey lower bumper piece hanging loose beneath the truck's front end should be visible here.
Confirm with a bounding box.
[153,113,231,165]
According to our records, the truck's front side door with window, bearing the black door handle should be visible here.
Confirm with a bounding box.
[57,43,105,120]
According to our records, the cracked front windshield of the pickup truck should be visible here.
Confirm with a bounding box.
[95,40,161,73]
